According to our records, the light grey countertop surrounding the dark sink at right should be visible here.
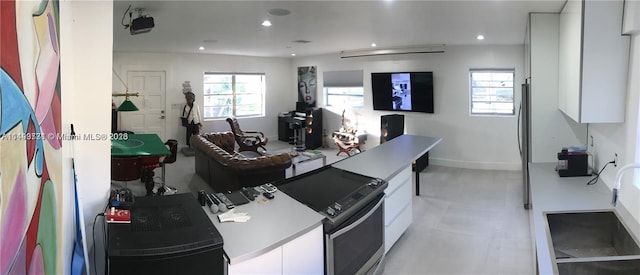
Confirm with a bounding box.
[529,163,640,275]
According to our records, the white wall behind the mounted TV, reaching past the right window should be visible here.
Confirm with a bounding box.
[290,45,524,170]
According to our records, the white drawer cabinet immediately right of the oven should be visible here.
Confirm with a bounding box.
[384,166,413,253]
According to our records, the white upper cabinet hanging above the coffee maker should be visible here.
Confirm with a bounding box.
[558,0,630,123]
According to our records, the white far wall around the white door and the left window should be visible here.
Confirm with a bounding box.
[113,52,297,145]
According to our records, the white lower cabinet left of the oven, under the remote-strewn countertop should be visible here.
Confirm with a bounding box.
[228,225,324,275]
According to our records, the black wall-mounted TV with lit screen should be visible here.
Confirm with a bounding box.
[371,72,433,113]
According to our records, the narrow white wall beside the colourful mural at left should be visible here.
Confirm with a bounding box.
[60,1,113,274]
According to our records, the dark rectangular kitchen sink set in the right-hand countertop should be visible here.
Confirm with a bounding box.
[546,210,640,275]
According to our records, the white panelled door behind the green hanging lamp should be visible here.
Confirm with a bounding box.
[120,71,166,140]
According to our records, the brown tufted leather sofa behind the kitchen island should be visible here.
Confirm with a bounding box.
[190,132,291,192]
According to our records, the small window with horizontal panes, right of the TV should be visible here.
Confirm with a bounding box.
[469,69,515,116]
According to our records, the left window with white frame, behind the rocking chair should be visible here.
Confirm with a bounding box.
[203,73,265,119]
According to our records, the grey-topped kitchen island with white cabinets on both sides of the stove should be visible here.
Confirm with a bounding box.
[205,135,442,274]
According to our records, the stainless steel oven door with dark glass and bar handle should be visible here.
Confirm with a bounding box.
[326,195,384,275]
